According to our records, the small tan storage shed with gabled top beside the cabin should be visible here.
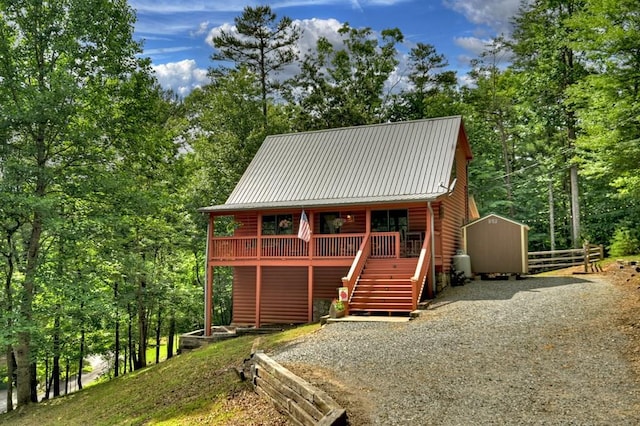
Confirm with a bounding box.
[462,214,529,274]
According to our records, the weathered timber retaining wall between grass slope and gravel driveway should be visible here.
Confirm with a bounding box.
[251,351,347,426]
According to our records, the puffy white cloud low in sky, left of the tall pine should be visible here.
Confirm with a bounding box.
[153,59,209,97]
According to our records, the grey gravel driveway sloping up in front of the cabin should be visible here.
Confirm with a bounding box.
[273,277,640,425]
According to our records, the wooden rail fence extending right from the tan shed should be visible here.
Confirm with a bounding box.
[529,244,604,273]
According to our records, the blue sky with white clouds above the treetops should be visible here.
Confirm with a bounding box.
[129,0,520,96]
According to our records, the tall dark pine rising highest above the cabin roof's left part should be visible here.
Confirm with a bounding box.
[212,6,300,122]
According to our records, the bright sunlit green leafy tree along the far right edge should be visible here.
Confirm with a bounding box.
[569,0,640,241]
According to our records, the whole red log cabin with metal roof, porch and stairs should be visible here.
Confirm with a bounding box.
[200,116,472,335]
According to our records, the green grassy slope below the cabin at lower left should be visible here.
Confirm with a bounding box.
[0,324,319,425]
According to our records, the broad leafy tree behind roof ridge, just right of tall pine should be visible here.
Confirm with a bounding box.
[287,24,403,130]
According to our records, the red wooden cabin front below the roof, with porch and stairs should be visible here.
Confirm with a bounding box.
[205,203,442,333]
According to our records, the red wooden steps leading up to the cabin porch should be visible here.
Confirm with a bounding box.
[349,258,418,314]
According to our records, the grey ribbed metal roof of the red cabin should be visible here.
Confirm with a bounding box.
[200,116,471,212]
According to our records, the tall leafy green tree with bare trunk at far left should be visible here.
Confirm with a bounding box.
[0,0,140,405]
